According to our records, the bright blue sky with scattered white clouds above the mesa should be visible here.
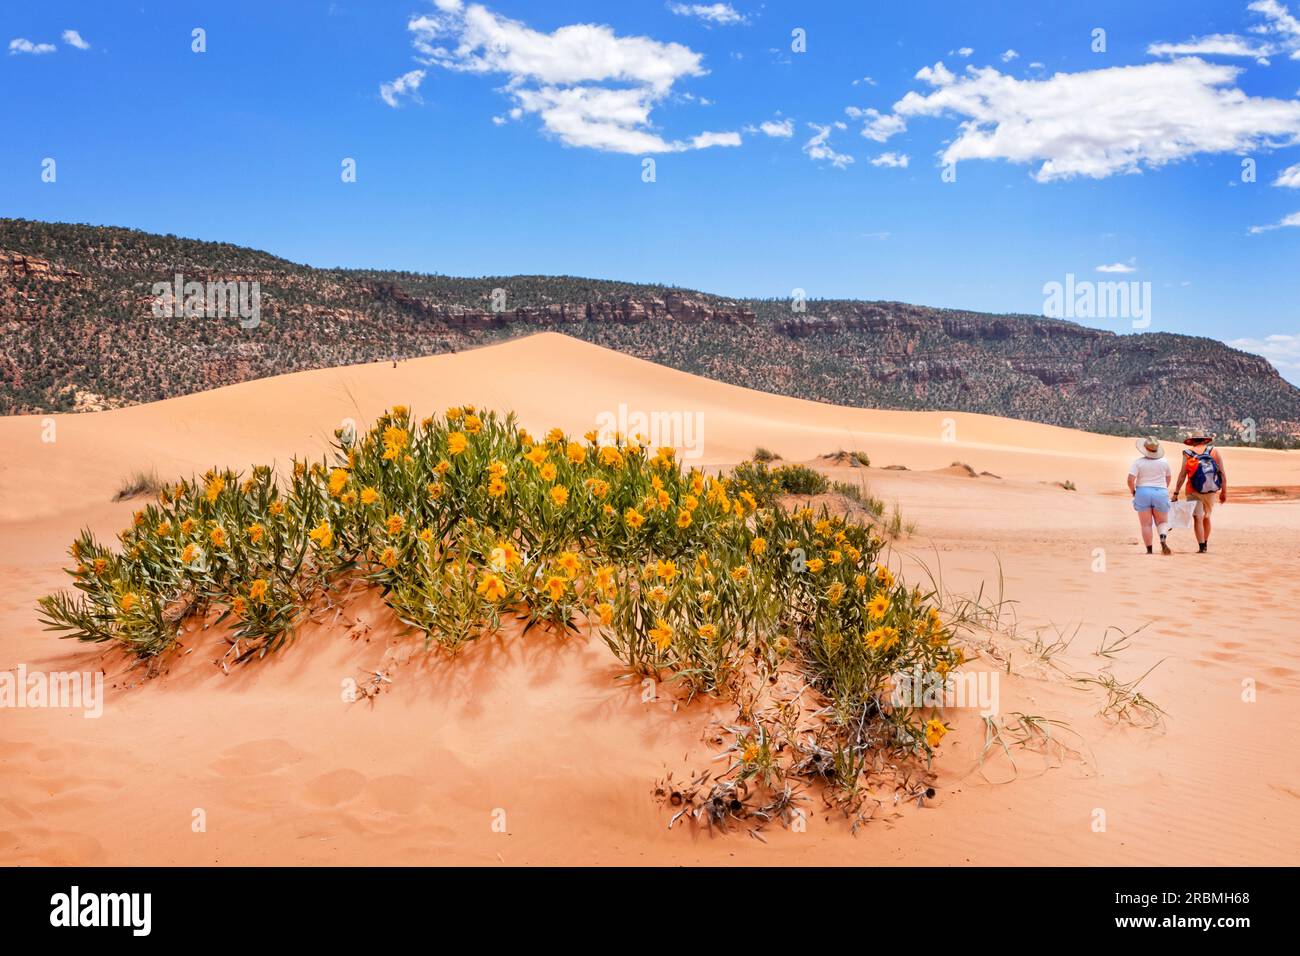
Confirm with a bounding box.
[0,0,1300,381]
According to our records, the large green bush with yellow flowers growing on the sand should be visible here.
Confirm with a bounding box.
[40,406,961,806]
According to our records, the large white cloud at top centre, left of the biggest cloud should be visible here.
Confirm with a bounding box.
[407,0,740,153]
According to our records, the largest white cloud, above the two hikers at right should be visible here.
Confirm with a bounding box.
[865,57,1300,182]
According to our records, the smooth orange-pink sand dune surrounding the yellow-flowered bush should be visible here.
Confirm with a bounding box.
[0,334,1300,865]
